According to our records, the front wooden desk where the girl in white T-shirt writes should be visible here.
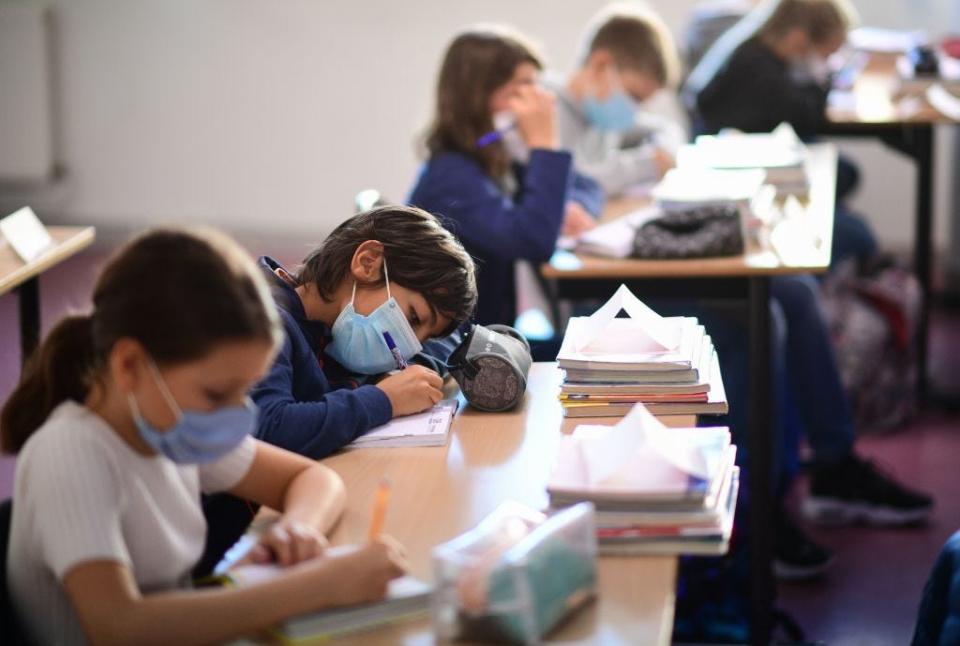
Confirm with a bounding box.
[324,363,695,646]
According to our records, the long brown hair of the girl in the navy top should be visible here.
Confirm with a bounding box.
[426,26,543,178]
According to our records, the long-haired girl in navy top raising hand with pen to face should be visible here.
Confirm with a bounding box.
[408,27,603,325]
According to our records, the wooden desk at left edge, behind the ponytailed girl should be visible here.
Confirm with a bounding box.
[0,227,95,362]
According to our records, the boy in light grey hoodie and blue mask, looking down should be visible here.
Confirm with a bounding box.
[548,4,686,196]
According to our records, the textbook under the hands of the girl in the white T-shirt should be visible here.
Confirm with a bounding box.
[221,548,432,644]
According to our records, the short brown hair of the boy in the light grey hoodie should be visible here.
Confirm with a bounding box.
[582,3,680,87]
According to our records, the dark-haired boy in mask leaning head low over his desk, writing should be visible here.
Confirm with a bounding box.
[251,206,476,458]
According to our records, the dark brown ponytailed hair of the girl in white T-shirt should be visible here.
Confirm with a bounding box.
[0,229,283,452]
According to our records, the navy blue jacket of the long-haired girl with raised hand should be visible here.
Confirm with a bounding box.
[407,149,603,325]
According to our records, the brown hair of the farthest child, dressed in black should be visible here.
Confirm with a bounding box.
[758,0,857,44]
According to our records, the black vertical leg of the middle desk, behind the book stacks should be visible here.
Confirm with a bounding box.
[748,276,776,645]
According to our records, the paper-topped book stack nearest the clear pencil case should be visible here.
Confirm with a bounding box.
[547,404,739,555]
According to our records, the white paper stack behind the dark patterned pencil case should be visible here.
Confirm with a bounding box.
[677,123,810,197]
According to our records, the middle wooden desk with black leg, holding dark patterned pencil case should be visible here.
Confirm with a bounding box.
[541,144,837,643]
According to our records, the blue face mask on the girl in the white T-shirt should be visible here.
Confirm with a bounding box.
[127,359,257,464]
